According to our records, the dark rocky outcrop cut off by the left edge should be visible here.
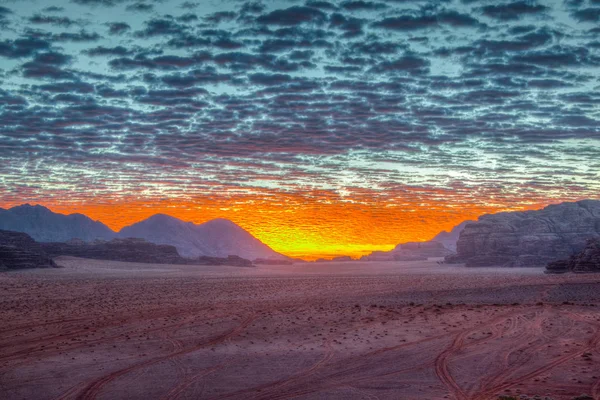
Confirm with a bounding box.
[0,230,56,270]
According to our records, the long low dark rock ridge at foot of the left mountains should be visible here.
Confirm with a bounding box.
[40,238,188,264]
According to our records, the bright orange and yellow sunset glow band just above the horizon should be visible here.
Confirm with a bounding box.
[0,190,576,260]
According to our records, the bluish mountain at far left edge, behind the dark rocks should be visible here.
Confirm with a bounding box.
[0,204,116,242]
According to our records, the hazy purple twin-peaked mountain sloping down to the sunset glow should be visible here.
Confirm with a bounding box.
[118,214,286,260]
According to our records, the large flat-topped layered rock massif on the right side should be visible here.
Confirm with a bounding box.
[446,200,600,267]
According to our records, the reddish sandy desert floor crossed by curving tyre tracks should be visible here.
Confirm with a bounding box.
[0,258,600,400]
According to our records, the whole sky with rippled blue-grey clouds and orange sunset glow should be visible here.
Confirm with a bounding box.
[0,0,600,259]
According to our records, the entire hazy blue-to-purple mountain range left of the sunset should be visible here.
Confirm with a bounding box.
[0,204,287,260]
